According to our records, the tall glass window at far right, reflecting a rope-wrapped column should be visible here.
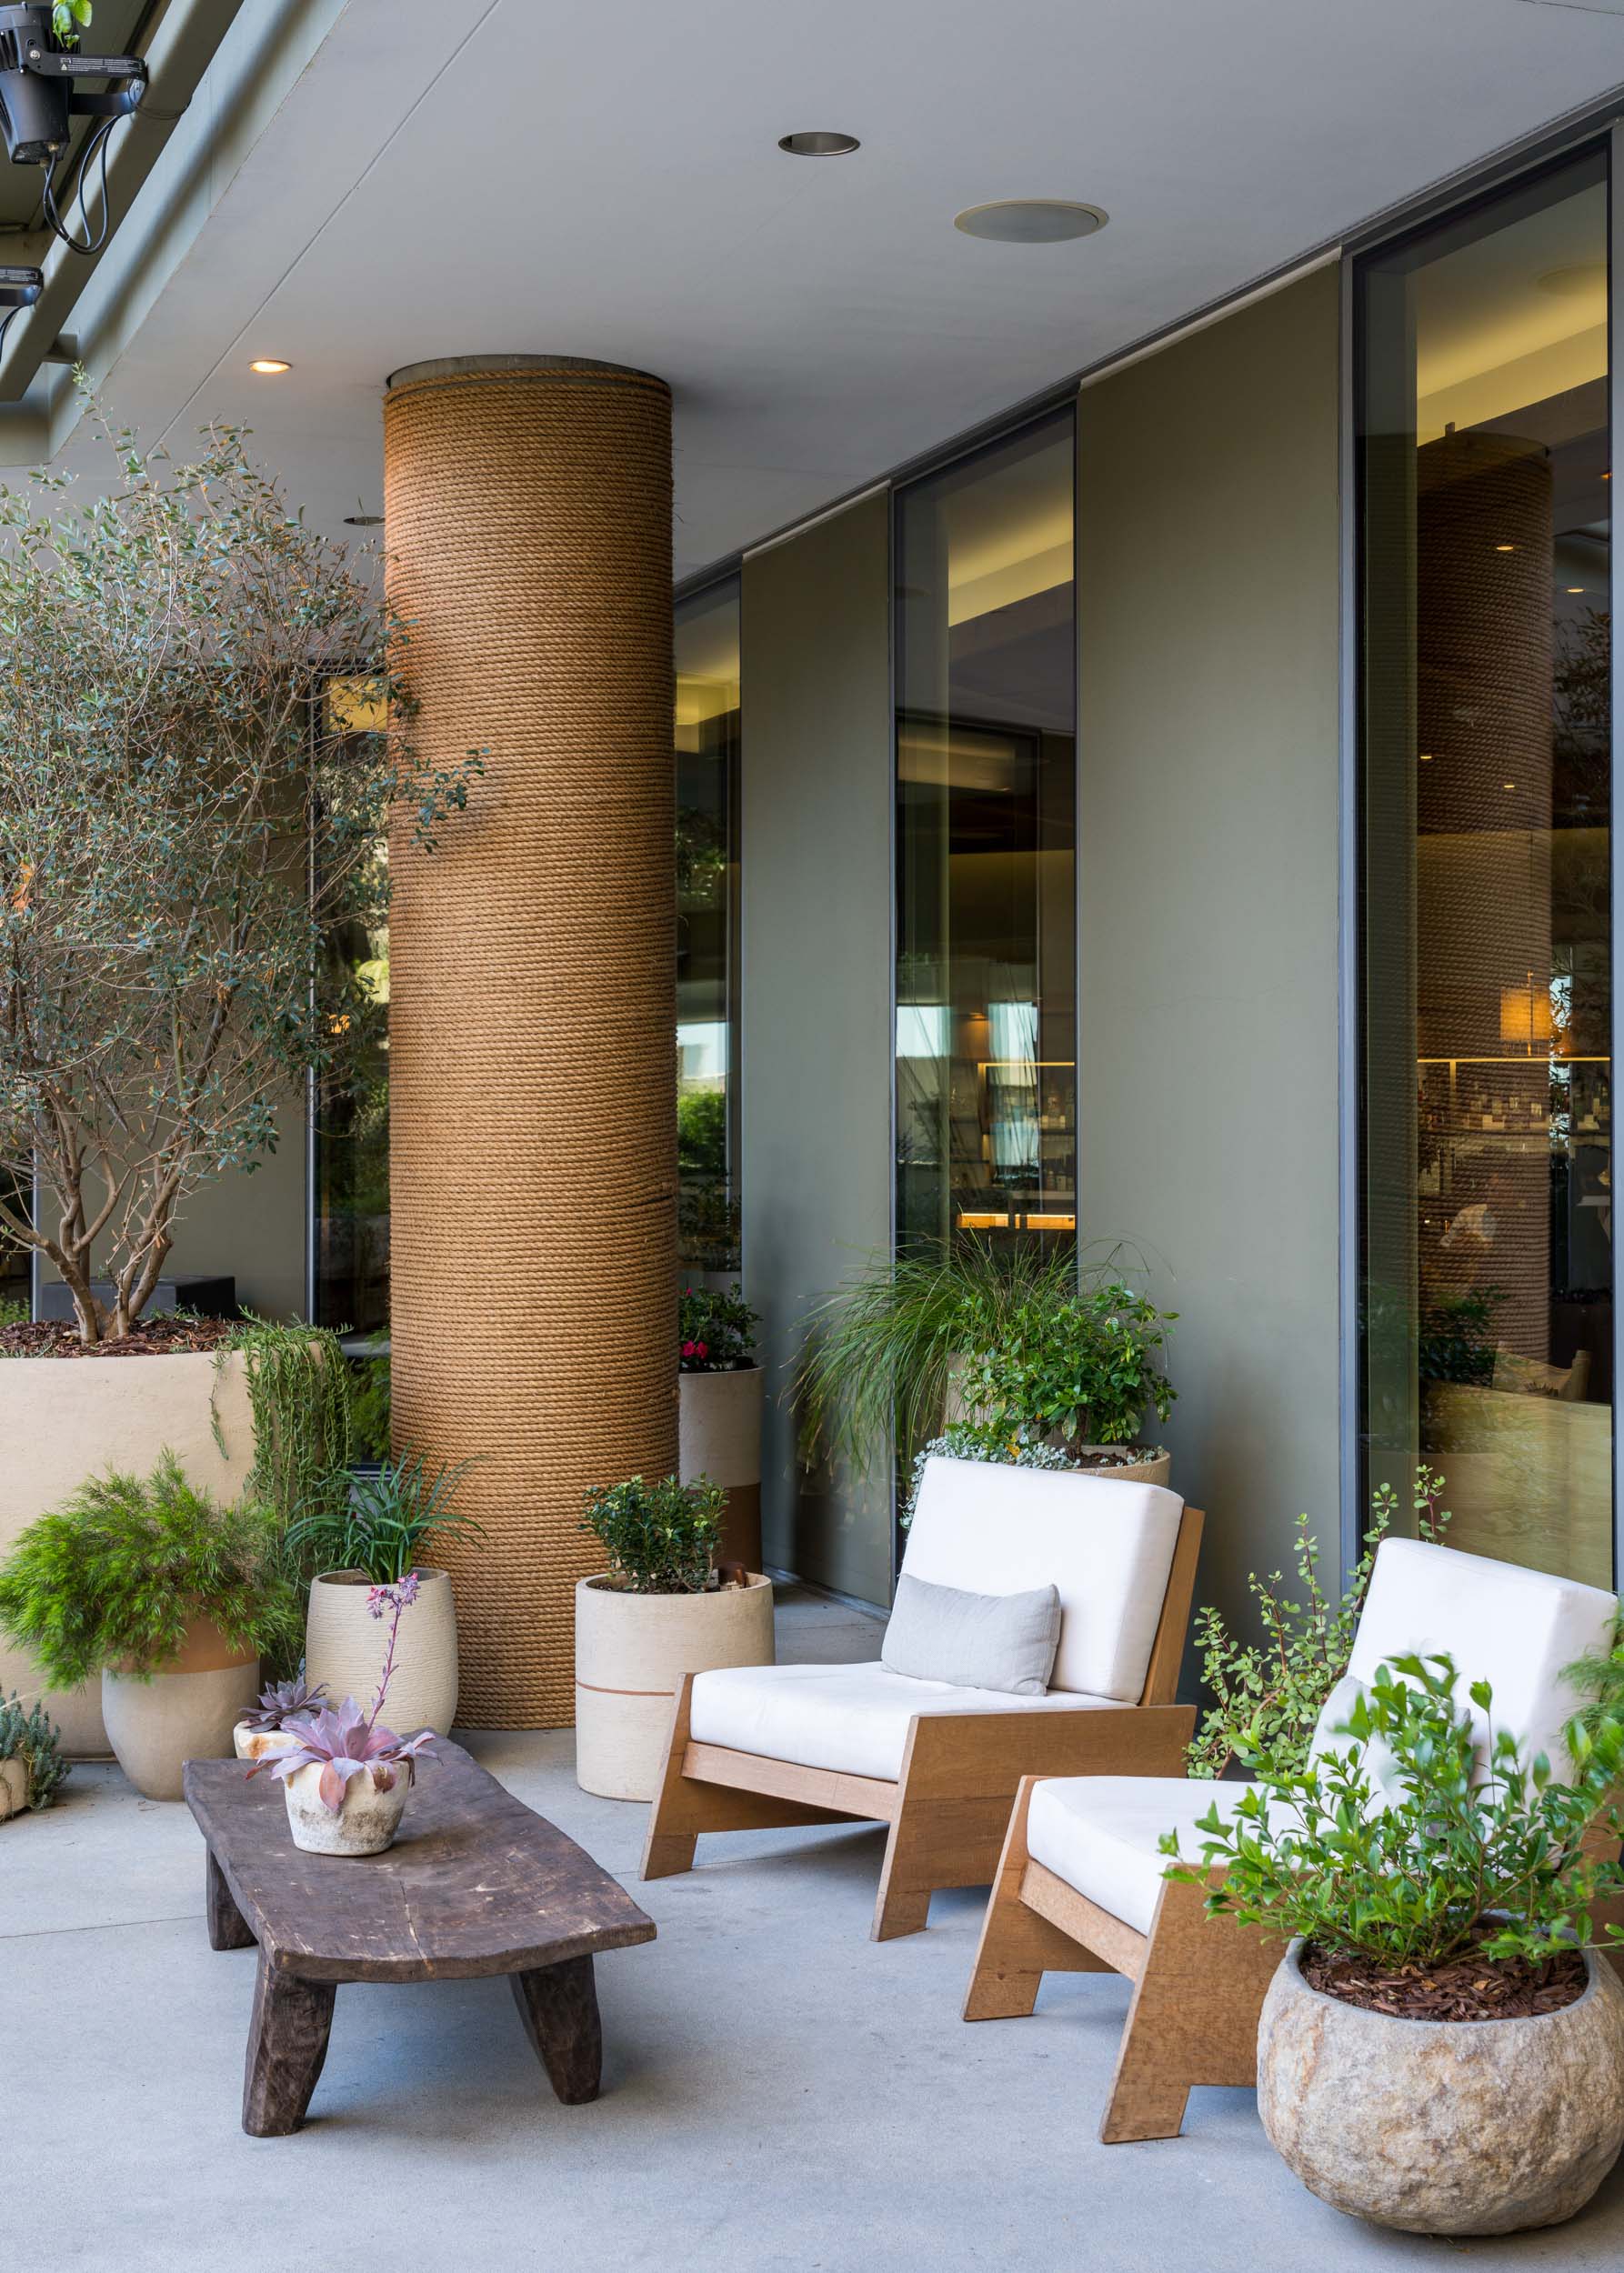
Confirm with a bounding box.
[1358,153,1612,1587]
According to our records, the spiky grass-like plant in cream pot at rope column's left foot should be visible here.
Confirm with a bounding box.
[286,1453,485,1737]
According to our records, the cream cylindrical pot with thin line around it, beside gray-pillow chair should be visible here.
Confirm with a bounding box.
[576,1576,773,1800]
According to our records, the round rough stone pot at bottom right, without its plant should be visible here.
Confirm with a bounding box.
[1258,1941,1624,2235]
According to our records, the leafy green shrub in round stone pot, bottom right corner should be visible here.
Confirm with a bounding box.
[1165,1655,1624,2235]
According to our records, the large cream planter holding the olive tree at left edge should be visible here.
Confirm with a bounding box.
[0,1350,255,1759]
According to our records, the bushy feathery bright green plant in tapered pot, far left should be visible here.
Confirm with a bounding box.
[0,1453,298,1800]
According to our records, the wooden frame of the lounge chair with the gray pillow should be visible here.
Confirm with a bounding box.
[641,1507,1203,1941]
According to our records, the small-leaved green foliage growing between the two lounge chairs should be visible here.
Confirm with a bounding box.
[1188,1468,1449,1776]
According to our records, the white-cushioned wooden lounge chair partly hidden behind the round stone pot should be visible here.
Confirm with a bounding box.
[965,1539,1617,2144]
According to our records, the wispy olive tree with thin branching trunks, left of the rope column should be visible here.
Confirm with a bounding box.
[0,402,480,1344]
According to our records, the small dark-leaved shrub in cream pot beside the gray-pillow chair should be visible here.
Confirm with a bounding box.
[576,1476,773,1800]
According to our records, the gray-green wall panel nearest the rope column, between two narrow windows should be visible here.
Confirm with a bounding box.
[739,496,892,1603]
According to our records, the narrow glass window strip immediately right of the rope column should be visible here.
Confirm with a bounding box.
[676,577,739,1273]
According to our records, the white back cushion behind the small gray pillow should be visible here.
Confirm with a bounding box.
[903,1459,1185,1705]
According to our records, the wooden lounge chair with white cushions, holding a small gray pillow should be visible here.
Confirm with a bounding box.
[644,1459,1201,1941]
